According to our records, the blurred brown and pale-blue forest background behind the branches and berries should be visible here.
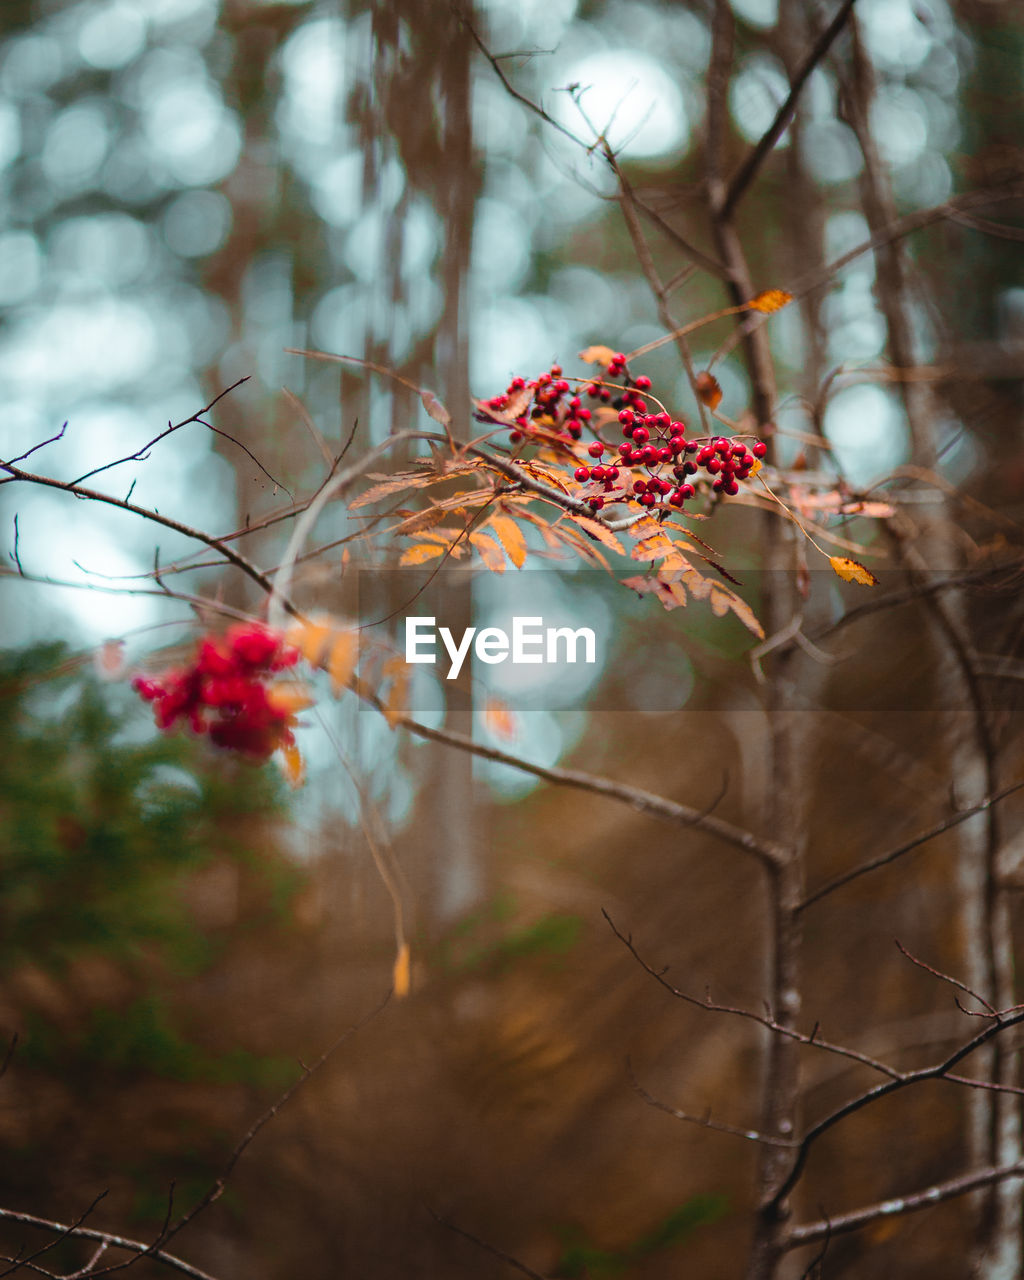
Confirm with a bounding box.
[0,0,1024,1280]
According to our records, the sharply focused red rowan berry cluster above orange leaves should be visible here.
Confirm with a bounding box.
[477,352,768,511]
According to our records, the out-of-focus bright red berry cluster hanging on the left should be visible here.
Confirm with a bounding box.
[132,623,300,760]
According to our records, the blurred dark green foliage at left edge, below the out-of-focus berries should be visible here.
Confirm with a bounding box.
[0,645,297,1087]
